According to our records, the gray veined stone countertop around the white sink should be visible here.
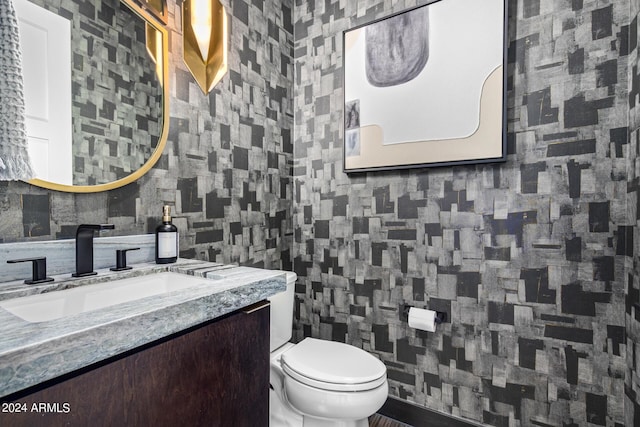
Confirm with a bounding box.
[0,259,286,397]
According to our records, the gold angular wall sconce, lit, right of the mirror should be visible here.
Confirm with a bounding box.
[182,0,227,93]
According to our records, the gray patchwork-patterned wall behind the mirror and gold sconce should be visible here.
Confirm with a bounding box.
[0,0,293,269]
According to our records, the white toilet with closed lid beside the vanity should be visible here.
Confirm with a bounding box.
[269,272,389,427]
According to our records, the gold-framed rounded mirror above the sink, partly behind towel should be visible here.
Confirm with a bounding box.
[14,0,169,193]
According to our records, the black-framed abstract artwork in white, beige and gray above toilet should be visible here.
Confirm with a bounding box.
[343,0,507,173]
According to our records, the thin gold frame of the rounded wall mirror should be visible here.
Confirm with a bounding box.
[27,0,169,193]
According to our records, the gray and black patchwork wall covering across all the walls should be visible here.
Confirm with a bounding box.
[0,0,640,426]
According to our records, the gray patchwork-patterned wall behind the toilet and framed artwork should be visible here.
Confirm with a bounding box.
[293,0,638,426]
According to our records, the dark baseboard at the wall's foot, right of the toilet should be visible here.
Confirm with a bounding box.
[378,397,481,427]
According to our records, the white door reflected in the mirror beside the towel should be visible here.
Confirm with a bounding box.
[14,0,73,185]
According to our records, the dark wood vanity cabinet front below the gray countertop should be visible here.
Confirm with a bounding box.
[0,303,269,427]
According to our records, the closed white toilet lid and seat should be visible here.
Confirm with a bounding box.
[282,338,387,391]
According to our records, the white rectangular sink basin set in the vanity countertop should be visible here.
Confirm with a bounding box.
[0,272,207,322]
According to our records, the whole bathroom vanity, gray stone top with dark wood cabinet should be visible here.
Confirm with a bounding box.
[0,259,286,427]
